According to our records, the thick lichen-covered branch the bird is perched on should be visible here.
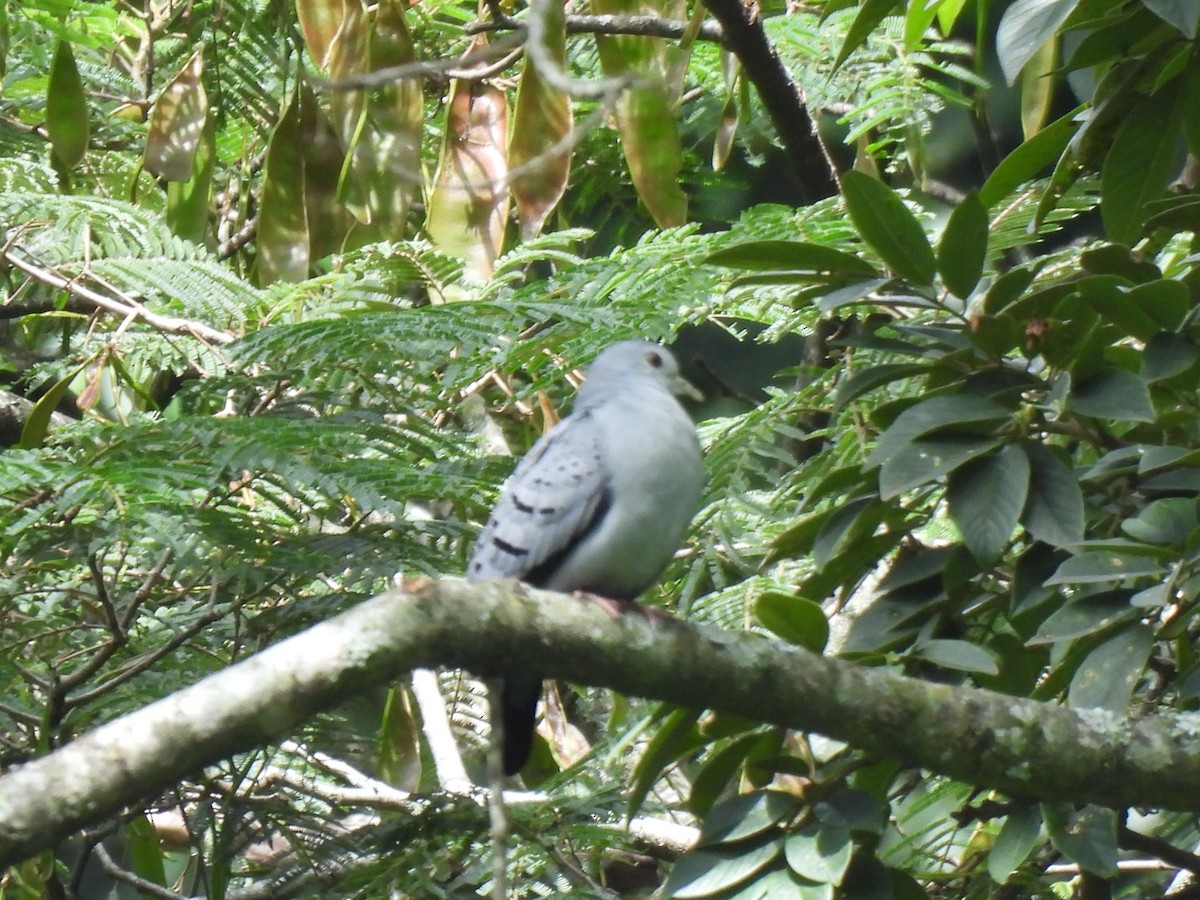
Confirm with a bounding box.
[0,581,1200,868]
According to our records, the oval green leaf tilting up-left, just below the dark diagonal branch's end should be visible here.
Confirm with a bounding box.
[841,170,937,286]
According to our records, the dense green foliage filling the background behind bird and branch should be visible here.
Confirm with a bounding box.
[0,0,1200,898]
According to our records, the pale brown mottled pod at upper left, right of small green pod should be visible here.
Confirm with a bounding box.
[142,47,209,181]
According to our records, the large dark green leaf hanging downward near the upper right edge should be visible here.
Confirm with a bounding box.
[1100,75,1190,245]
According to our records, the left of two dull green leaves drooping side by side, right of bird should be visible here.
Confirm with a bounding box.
[946,444,1030,565]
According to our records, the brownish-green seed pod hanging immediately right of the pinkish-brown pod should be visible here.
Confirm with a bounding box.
[509,2,572,241]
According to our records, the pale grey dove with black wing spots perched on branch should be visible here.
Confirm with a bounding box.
[467,341,704,775]
